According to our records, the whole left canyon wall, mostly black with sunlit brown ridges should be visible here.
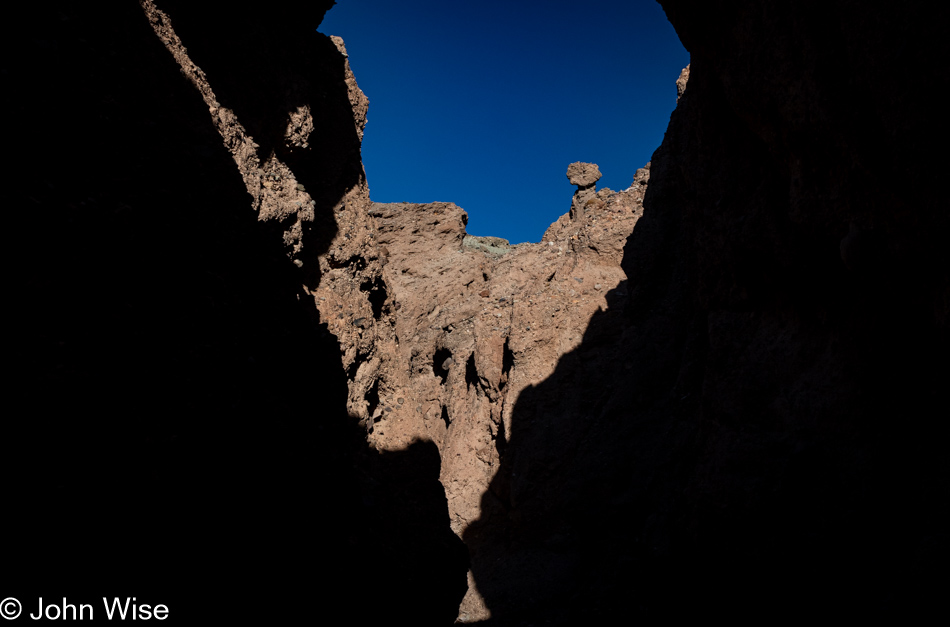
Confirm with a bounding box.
[18,0,467,625]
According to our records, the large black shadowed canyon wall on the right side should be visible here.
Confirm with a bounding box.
[465,0,950,625]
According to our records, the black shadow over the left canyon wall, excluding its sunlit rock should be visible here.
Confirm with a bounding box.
[6,2,465,624]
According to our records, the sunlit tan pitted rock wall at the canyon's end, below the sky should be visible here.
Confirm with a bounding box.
[316,169,645,621]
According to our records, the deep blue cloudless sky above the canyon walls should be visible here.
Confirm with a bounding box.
[319,0,689,243]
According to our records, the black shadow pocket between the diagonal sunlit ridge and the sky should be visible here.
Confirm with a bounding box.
[151,0,363,290]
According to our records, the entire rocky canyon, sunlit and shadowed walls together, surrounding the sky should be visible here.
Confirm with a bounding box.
[9,0,950,625]
